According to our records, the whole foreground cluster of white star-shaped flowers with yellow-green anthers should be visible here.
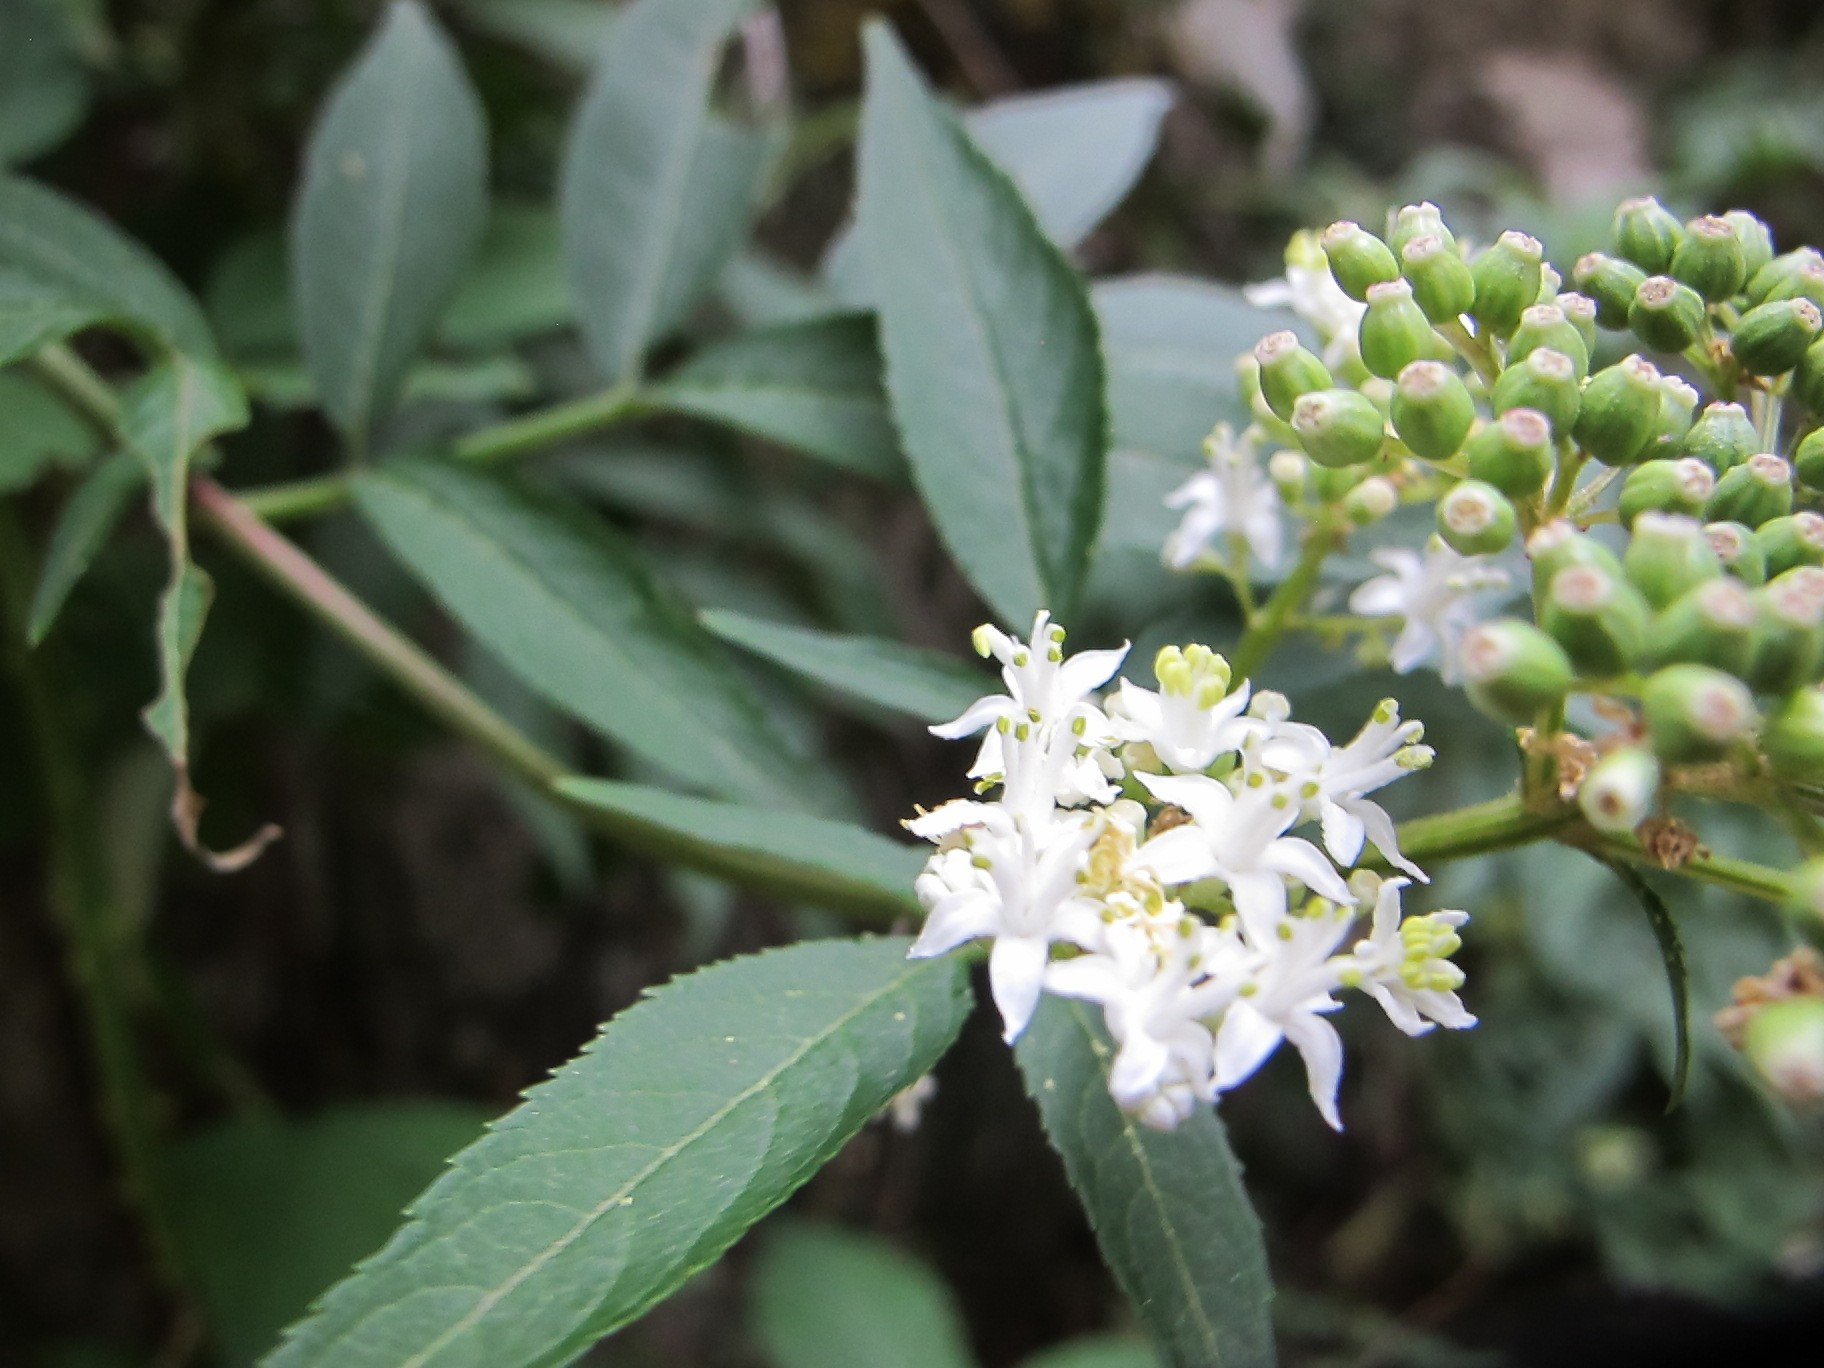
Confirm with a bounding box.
[907,613,1476,1129]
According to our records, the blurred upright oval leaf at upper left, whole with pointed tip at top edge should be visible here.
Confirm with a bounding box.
[292,0,487,438]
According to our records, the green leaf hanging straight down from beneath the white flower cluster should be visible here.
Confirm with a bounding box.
[1016,998,1273,1368]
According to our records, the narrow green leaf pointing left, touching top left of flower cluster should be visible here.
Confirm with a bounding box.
[699,609,994,722]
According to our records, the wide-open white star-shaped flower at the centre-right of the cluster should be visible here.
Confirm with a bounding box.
[1135,773,1355,948]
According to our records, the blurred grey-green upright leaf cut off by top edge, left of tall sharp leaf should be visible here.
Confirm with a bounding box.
[558,0,768,379]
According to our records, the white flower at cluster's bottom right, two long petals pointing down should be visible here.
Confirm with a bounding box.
[1215,903,1355,1131]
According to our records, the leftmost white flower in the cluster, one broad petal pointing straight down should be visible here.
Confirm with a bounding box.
[910,803,1102,1040]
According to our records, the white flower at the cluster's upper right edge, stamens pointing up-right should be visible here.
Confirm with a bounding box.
[1260,699,1432,883]
